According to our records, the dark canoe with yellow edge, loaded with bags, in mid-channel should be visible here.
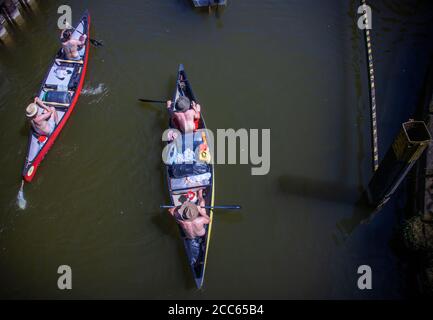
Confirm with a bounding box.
[165,65,215,289]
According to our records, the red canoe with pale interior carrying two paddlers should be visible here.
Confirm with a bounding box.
[22,11,90,182]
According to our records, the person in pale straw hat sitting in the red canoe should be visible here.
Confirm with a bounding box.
[26,97,59,136]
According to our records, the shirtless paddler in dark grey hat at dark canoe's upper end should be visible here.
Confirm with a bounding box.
[167,96,201,133]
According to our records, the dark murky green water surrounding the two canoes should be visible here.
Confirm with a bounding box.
[0,0,433,299]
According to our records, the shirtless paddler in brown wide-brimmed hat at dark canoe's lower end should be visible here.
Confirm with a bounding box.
[168,190,210,265]
